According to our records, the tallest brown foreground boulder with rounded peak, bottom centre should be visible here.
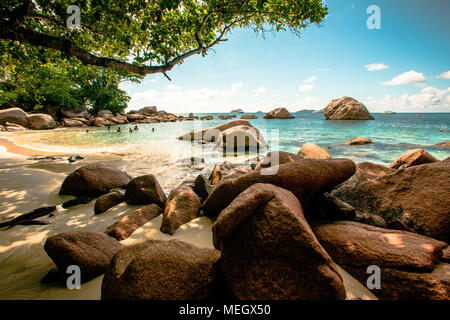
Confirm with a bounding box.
[213,183,346,300]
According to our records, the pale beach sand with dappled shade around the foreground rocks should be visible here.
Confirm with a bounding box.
[0,142,375,299]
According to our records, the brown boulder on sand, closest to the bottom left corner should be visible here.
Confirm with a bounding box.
[44,231,122,282]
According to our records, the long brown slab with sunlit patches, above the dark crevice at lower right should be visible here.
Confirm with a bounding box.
[311,221,447,272]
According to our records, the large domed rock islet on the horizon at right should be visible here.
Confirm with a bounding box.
[323,97,375,120]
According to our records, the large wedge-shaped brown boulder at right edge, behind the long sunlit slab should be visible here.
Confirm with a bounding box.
[333,158,450,242]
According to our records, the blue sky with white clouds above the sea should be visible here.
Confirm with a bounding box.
[121,0,450,113]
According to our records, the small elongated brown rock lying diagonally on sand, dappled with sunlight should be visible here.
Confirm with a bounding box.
[105,204,162,240]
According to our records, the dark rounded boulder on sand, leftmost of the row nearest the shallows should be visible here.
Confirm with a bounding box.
[59,163,131,197]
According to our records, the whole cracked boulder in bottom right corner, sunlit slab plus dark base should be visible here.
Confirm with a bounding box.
[312,221,450,300]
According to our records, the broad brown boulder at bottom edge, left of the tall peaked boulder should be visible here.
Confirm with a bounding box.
[102,240,220,300]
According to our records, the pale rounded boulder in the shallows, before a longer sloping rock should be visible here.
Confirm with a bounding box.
[216,125,267,152]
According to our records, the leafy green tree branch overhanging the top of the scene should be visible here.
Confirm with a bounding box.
[0,0,327,76]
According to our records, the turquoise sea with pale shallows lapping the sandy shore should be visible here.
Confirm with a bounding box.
[7,113,450,191]
